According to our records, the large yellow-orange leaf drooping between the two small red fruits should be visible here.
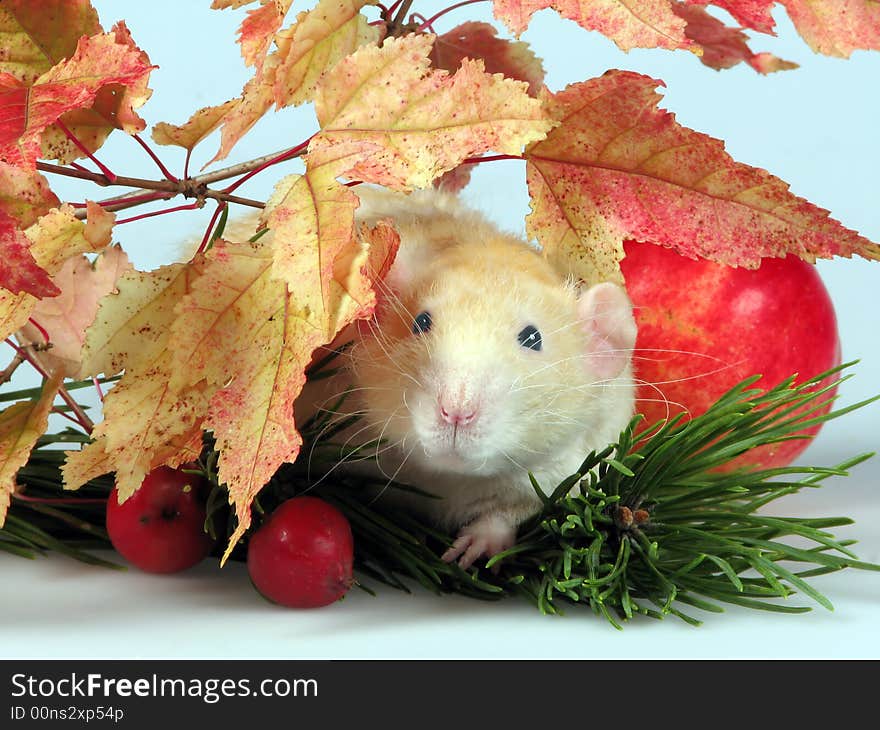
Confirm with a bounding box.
[166,175,397,559]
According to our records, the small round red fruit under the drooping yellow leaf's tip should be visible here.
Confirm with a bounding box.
[247,497,354,608]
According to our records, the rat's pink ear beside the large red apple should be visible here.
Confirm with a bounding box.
[578,281,636,378]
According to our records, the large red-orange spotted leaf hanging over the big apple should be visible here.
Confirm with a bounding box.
[525,71,880,281]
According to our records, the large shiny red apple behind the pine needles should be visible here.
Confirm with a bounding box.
[621,241,840,468]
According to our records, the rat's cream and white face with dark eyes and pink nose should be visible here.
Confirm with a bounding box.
[351,244,634,476]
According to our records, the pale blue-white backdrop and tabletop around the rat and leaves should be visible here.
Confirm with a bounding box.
[0,0,880,658]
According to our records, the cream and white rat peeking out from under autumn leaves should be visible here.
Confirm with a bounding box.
[312,186,636,567]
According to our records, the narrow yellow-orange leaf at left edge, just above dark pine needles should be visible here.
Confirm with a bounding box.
[0,371,64,527]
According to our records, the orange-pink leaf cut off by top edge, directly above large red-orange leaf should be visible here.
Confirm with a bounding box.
[495,0,691,51]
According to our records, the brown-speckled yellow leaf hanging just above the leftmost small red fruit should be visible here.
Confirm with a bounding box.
[63,259,211,500]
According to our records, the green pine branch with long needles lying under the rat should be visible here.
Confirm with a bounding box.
[6,365,880,628]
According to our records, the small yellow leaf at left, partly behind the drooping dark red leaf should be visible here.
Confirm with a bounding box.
[0,202,115,338]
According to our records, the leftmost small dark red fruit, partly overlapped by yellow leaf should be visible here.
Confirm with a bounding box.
[107,466,214,573]
